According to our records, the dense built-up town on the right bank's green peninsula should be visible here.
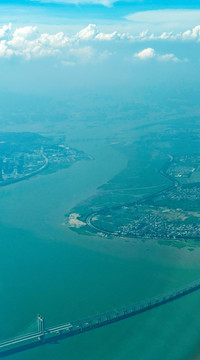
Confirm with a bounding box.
[103,155,200,240]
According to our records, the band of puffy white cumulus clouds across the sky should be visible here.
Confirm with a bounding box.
[0,24,197,64]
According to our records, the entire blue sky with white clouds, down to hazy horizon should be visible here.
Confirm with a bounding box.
[0,0,200,102]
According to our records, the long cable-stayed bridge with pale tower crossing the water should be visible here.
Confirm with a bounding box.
[0,280,200,358]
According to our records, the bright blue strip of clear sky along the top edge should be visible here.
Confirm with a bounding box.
[1,0,200,20]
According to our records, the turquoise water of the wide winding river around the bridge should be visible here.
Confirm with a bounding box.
[0,140,200,360]
